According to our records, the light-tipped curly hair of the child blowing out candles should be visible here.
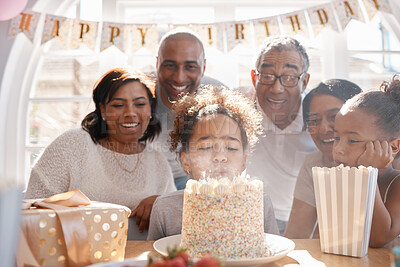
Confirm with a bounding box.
[170,85,263,152]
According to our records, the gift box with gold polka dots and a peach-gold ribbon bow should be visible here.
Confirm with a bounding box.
[17,190,131,266]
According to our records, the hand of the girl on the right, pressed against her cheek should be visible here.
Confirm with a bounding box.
[357,140,393,169]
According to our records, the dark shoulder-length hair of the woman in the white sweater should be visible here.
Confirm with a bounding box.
[81,68,161,144]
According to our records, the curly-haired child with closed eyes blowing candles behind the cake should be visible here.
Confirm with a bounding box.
[148,86,278,240]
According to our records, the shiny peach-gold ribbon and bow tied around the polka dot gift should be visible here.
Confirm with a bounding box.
[17,190,91,266]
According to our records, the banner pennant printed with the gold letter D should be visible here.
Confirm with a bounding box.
[307,4,338,36]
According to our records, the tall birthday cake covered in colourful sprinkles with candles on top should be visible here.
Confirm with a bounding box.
[181,178,268,259]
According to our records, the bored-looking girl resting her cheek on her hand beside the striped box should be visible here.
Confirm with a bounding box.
[333,76,400,247]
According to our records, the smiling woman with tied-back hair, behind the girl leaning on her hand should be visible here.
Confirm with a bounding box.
[285,79,361,238]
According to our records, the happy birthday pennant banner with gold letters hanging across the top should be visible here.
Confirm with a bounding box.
[8,0,392,54]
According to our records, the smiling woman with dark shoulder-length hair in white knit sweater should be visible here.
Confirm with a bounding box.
[26,69,175,238]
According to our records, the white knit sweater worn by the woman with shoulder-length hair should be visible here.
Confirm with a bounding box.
[25,129,176,209]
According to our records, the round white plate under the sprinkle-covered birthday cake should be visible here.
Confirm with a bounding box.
[153,233,295,266]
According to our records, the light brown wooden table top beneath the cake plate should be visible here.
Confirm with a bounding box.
[125,238,400,267]
